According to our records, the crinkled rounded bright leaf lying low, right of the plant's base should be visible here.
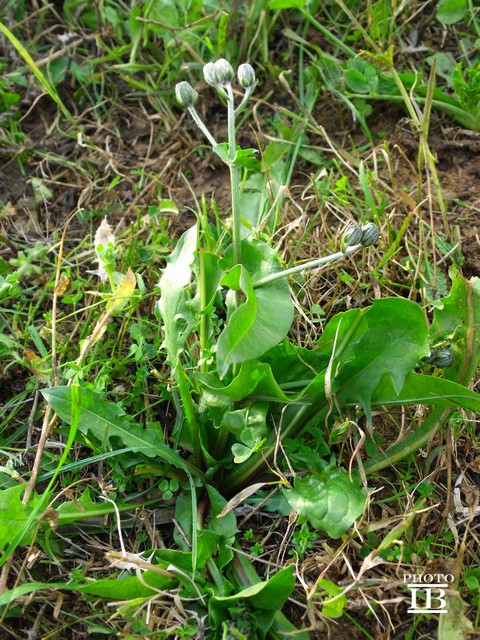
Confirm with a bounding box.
[285,469,367,538]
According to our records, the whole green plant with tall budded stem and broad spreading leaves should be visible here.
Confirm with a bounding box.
[0,53,480,639]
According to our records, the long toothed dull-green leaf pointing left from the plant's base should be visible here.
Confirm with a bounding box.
[42,386,187,470]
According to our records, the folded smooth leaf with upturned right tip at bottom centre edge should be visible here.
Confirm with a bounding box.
[209,565,295,638]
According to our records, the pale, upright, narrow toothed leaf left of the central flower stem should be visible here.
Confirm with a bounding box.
[158,225,197,368]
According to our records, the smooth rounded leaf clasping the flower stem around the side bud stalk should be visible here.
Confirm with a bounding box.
[217,239,294,377]
